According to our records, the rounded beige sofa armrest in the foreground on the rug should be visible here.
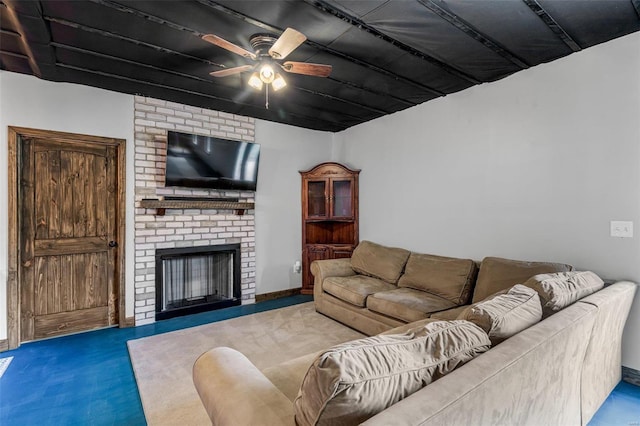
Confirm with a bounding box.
[193,347,295,426]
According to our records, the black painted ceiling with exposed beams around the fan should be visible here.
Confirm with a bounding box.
[0,0,640,131]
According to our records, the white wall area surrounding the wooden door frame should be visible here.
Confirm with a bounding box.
[0,71,133,339]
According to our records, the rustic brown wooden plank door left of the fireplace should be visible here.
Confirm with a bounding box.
[19,137,119,341]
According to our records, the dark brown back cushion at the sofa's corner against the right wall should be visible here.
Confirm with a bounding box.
[473,257,573,303]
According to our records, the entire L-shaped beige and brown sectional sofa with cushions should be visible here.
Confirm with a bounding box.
[193,242,636,425]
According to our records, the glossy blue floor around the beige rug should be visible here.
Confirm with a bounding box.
[0,296,640,426]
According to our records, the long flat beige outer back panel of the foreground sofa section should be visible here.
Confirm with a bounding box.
[363,304,596,426]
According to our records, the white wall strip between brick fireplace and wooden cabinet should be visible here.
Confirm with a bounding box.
[255,120,333,294]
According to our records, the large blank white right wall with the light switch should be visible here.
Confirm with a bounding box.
[335,33,640,369]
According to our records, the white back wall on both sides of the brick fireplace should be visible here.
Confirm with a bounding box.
[0,71,333,339]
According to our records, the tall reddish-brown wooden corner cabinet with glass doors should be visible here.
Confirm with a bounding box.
[300,163,360,294]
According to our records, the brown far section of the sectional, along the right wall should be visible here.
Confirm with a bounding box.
[311,241,572,335]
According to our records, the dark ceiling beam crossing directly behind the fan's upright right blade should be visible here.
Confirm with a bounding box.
[198,0,446,96]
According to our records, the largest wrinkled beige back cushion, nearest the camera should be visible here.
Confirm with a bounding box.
[294,321,491,426]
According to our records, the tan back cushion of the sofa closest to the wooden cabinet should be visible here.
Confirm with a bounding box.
[351,241,410,284]
